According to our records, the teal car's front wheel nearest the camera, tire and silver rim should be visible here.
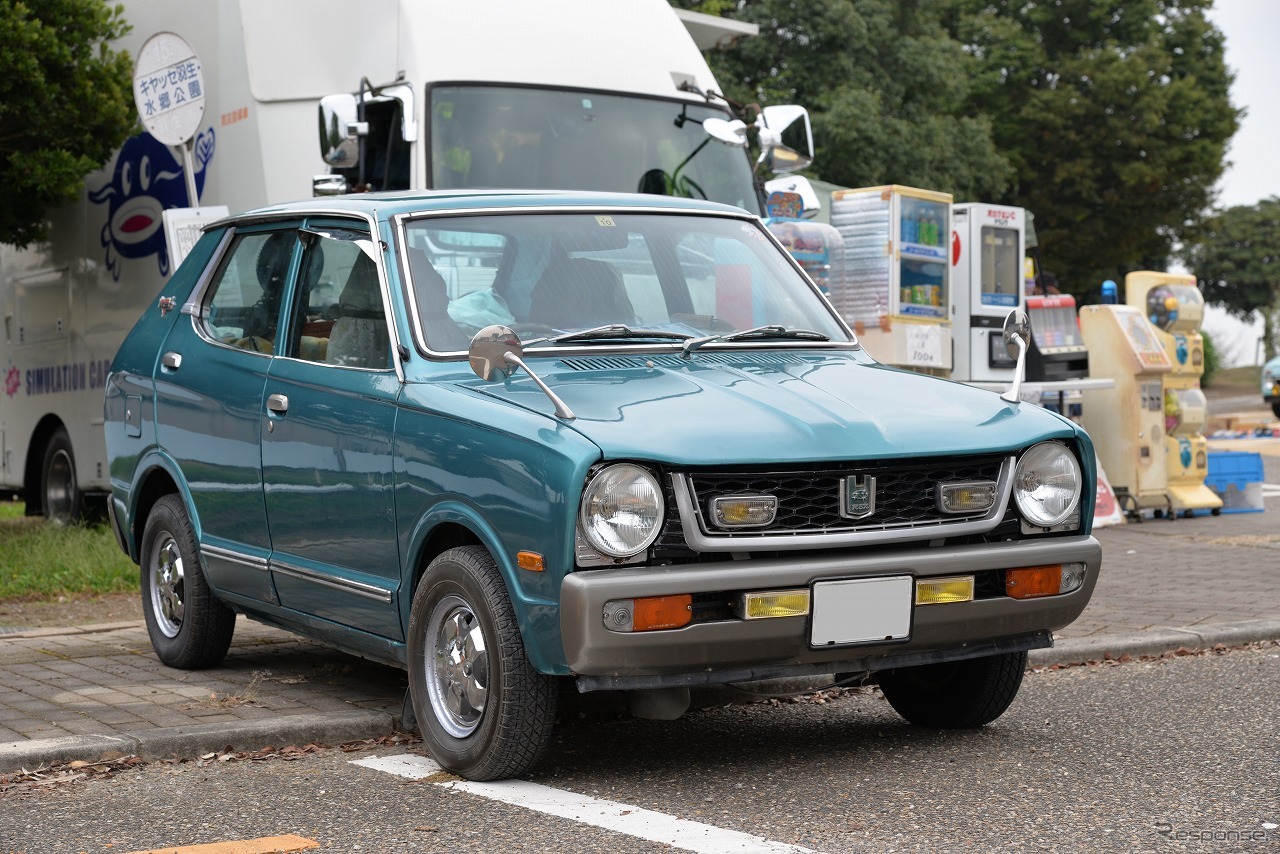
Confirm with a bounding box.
[408,545,557,780]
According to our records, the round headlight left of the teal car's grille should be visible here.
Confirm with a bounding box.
[579,463,663,557]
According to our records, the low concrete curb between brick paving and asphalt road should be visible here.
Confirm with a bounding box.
[0,620,1280,773]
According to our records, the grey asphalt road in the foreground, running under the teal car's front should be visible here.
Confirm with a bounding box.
[0,644,1280,854]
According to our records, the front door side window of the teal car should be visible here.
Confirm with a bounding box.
[288,228,390,370]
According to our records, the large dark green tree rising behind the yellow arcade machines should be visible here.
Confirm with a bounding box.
[945,0,1240,294]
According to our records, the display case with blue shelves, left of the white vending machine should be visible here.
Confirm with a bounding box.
[831,184,952,376]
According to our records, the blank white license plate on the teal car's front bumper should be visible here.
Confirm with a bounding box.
[810,575,915,647]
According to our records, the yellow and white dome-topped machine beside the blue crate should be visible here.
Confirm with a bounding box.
[1124,270,1222,516]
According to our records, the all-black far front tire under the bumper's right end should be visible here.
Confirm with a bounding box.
[879,652,1027,730]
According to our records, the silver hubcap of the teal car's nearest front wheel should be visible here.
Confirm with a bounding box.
[426,595,489,739]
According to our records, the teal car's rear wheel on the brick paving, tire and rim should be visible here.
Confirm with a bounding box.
[140,495,236,670]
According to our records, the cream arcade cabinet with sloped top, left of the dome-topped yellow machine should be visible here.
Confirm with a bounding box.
[1080,305,1174,519]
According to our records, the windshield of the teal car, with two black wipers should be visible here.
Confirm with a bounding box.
[404,211,850,352]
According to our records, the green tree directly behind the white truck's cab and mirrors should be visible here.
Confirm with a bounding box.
[672,0,1014,201]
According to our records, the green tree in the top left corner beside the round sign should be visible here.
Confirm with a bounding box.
[0,0,137,246]
